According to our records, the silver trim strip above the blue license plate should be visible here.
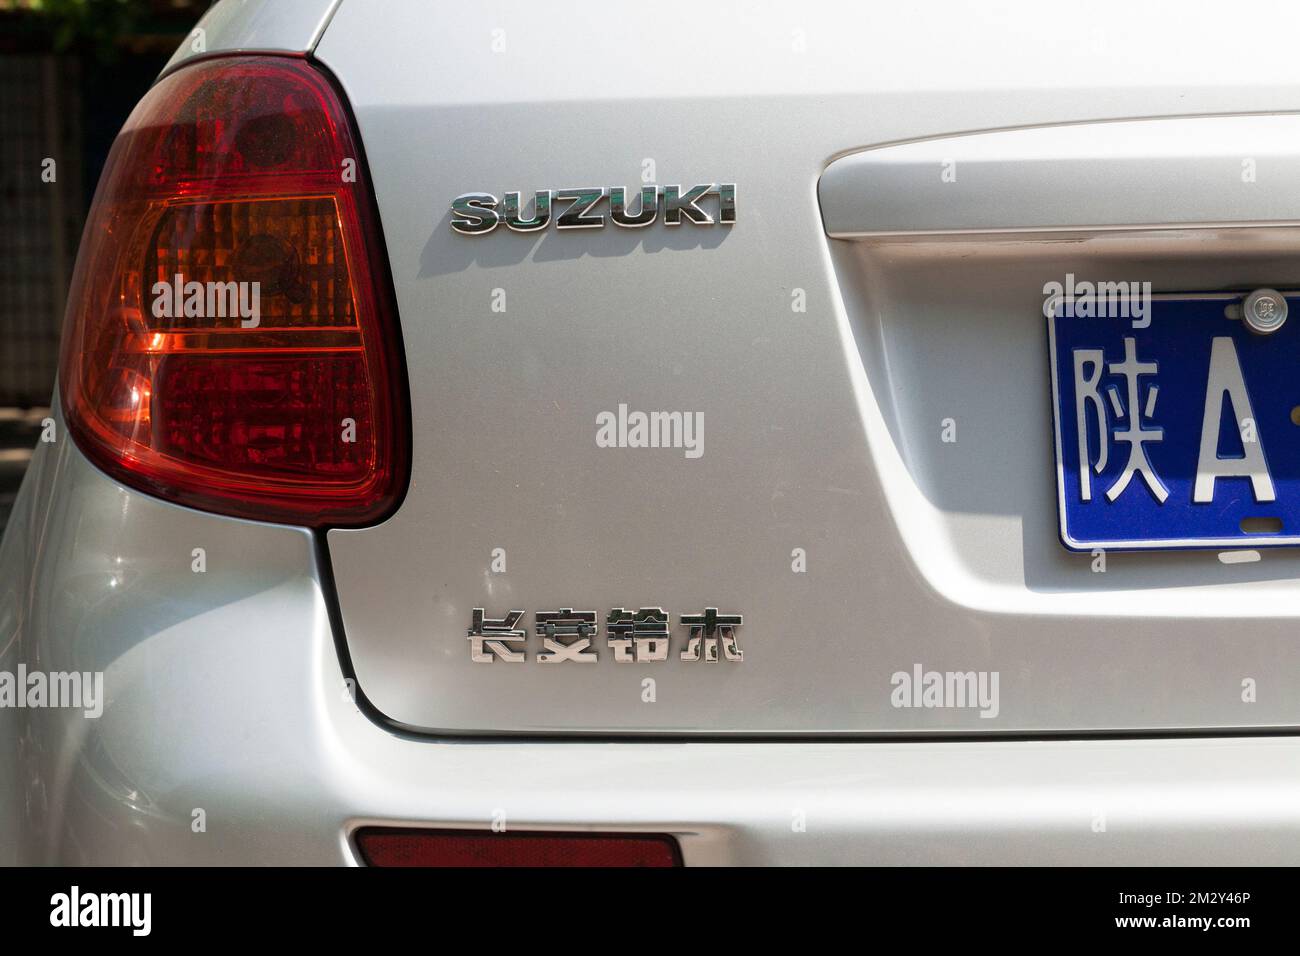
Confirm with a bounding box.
[818,113,1300,239]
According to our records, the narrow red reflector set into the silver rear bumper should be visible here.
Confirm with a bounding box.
[356,827,681,866]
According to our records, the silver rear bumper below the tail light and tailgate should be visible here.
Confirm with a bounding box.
[0,421,1300,865]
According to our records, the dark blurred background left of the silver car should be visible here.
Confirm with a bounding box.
[0,0,212,529]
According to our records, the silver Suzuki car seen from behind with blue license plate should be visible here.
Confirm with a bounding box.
[0,0,1300,865]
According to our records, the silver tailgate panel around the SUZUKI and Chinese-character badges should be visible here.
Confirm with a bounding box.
[317,1,1300,735]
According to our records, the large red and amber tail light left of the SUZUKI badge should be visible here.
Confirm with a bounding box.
[60,56,408,525]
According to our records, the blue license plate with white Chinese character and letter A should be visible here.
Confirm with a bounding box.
[1048,295,1300,550]
